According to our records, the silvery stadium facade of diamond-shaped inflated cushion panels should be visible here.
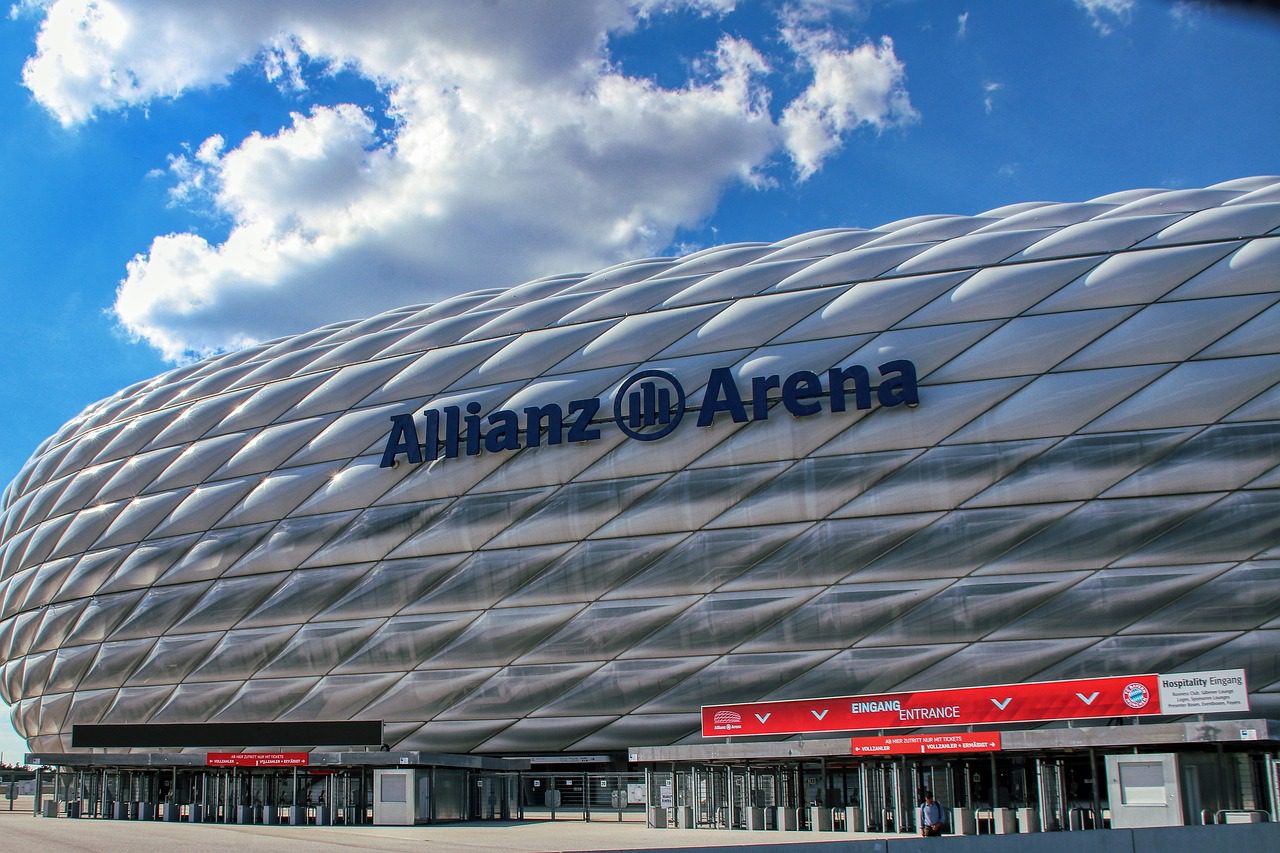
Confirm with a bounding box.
[0,177,1280,756]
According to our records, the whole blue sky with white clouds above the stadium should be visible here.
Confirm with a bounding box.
[0,0,1280,758]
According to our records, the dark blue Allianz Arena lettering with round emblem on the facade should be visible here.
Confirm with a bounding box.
[380,359,920,467]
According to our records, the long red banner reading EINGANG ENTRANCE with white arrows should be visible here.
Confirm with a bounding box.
[703,675,1160,738]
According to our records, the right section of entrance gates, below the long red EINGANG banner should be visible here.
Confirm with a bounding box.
[628,720,1280,834]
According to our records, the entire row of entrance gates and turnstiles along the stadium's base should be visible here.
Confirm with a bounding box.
[27,720,1280,834]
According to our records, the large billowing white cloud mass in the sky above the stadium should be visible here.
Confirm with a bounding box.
[23,0,915,360]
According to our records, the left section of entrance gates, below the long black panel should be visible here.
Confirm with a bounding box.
[27,752,646,826]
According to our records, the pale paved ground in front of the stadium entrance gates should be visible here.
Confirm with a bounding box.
[0,798,902,853]
